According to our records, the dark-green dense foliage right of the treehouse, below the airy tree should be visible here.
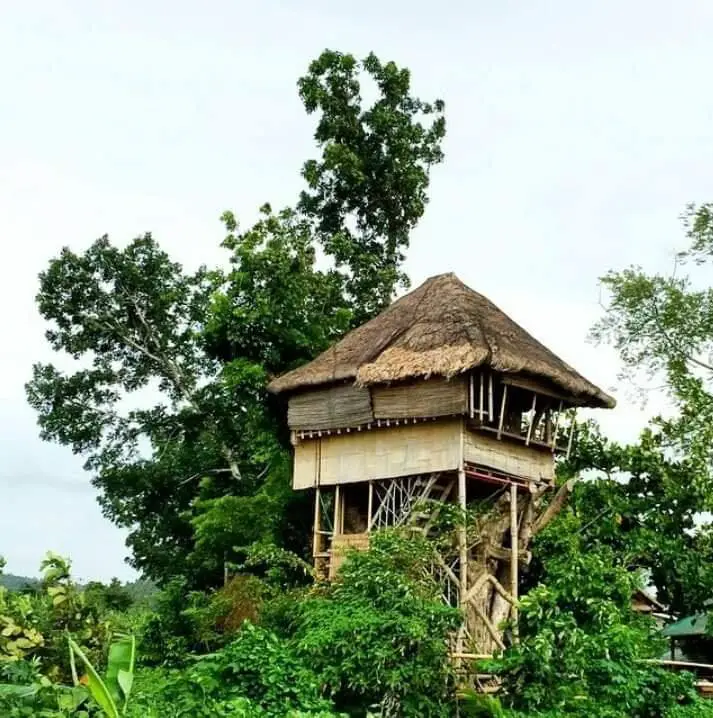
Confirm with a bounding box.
[552,425,713,614]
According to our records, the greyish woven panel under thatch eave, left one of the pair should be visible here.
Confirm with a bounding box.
[287,384,374,431]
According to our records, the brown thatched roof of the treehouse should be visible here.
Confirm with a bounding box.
[269,273,616,408]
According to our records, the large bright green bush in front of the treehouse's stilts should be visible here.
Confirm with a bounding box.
[282,533,460,716]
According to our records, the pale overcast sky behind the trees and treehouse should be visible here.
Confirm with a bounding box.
[0,0,713,579]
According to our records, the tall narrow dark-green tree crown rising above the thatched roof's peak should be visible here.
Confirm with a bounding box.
[299,51,445,324]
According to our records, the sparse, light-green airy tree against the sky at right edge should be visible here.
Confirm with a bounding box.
[593,204,713,493]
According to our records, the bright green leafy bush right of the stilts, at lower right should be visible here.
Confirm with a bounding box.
[496,511,696,718]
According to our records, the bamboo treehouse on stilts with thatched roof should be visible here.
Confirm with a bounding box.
[269,274,614,653]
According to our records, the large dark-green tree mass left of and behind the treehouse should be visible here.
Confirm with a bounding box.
[27,51,444,583]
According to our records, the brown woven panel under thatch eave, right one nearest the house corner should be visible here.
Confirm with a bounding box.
[371,376,468,419]
